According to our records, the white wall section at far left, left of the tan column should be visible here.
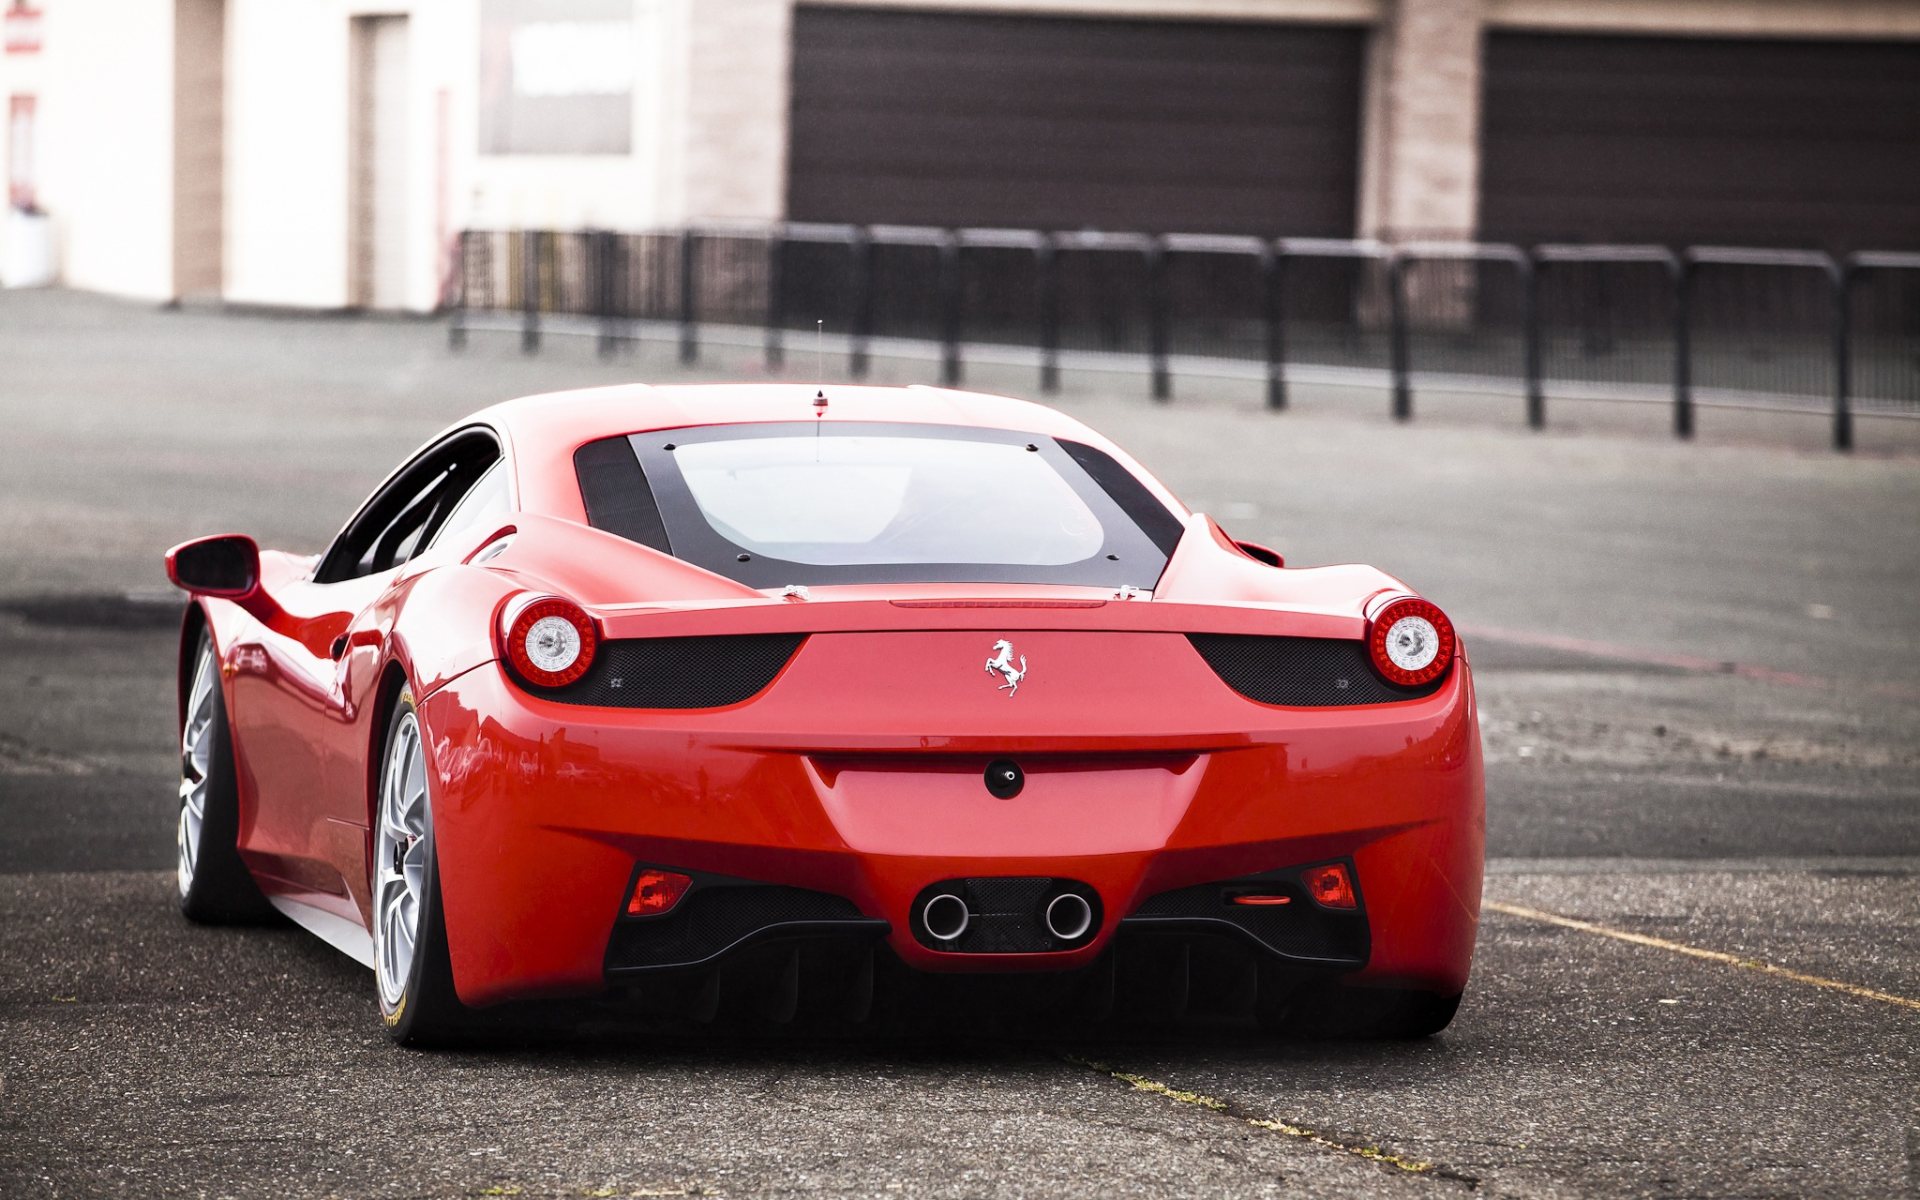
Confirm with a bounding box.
[0,0,173,300]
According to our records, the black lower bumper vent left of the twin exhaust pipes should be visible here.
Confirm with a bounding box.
[607,883,887,972]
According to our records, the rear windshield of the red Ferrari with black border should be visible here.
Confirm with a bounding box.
[582,422,1181,588]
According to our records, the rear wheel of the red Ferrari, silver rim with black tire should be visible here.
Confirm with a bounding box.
[372,693,468,1046]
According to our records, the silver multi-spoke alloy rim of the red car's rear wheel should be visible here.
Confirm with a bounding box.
[372,712,428,1008]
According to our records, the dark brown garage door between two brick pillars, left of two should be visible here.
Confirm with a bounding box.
[787,6,1363,236]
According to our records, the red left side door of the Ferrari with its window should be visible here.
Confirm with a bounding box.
[234,430,501,920]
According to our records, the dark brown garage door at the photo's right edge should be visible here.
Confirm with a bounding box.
[1480,33,1920,250]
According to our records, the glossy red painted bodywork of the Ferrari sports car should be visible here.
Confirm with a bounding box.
[182,386,1484,1004]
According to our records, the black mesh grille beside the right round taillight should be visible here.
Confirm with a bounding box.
[1187,634,1446,708]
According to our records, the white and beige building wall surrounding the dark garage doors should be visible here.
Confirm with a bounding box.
[0,0,1920,309]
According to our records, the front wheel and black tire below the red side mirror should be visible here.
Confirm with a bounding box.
[175,630,278,925]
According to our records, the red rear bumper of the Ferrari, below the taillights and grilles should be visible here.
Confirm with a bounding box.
[422,659,1484,1004]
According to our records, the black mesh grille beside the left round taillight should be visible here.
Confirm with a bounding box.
[528,634,806,708]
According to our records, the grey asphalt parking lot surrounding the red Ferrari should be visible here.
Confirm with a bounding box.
[0,292,1920,1196]
